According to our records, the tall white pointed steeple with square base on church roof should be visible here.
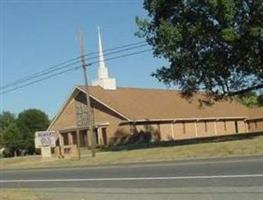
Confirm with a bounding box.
[92,27,116,90]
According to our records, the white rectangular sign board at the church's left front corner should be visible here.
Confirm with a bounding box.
[35,131,58,148]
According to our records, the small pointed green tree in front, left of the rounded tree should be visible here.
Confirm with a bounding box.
[3,121,23,156]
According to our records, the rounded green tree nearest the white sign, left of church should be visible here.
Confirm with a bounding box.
[17,109,49,153]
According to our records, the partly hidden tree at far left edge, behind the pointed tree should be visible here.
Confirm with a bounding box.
[0,111,15,147]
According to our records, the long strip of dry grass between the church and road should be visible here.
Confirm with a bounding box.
[0,136,263,169]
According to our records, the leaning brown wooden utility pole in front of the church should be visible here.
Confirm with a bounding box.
[78,29,96,157]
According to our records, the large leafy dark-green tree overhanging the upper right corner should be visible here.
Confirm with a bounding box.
[136,0,263,99]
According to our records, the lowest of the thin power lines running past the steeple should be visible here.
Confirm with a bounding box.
[0,49,152,95]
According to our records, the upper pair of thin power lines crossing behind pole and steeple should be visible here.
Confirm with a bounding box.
[0,42,147,90]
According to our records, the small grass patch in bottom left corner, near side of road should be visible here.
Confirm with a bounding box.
[0,189,42,200]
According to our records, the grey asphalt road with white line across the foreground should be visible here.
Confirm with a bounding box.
[0,156,263,200]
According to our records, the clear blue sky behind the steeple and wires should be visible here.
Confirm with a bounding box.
[0,0,165,118]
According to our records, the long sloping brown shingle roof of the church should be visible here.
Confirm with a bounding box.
[77,86,251,120]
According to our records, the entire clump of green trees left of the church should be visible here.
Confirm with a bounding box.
[0,109,49,156]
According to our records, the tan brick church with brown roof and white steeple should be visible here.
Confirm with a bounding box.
[48,28,263,147]
